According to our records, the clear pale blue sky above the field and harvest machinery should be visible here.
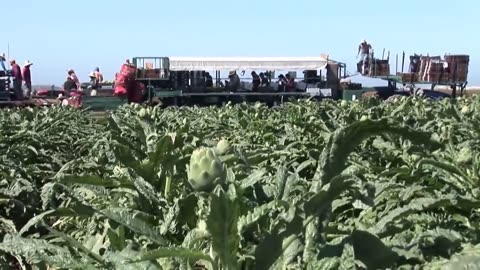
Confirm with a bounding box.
[0,0,480,85]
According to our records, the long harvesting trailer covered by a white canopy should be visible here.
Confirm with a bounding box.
[82,55,346,110]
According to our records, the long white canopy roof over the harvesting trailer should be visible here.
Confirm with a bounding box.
[169,56,329,71]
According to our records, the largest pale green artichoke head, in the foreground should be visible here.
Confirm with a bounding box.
[187,147,226,192]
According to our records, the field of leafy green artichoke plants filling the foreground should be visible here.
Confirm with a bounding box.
[0,97,480,270]
